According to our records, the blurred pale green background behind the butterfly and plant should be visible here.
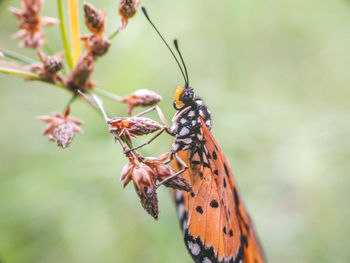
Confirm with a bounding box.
[0,0,350,263]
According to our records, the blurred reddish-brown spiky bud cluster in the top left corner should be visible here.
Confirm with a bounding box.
[9,0,59,48]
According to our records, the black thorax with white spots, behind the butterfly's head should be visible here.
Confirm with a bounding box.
[171,98,211,153]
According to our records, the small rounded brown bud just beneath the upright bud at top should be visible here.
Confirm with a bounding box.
[81,35,111,58]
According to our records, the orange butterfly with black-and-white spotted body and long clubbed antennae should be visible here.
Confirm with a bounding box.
[142,7,265,263]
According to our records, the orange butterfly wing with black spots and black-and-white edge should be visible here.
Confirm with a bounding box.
[172,119,265,263]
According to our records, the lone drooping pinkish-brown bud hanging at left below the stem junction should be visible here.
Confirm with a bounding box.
[37,108,83,148]
